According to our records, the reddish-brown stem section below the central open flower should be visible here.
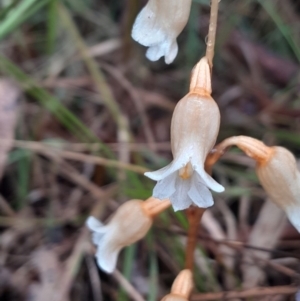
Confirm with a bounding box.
[185,207,205,271]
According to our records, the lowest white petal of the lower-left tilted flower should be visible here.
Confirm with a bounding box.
[95,237,120,273]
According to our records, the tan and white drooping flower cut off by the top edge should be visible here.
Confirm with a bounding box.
[131,0,192,64]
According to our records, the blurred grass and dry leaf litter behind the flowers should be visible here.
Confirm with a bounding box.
[0,0,300,301]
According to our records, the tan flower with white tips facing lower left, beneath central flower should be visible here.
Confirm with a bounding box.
[86,198,170,273]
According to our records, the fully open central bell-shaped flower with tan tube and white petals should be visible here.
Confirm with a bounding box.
[145,58,224,211]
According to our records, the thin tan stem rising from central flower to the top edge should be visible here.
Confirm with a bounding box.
[205,0,219,69]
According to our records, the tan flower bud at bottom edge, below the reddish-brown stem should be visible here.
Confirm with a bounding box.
[161,270,193,301]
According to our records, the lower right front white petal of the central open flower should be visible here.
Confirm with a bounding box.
[188,172,214,208]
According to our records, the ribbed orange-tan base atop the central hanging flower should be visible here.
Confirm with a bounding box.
[190,57,211,96]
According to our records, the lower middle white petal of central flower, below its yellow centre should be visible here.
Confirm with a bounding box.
[170,175,193,211]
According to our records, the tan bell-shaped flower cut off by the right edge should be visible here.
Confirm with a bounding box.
[256,146,300,232]
